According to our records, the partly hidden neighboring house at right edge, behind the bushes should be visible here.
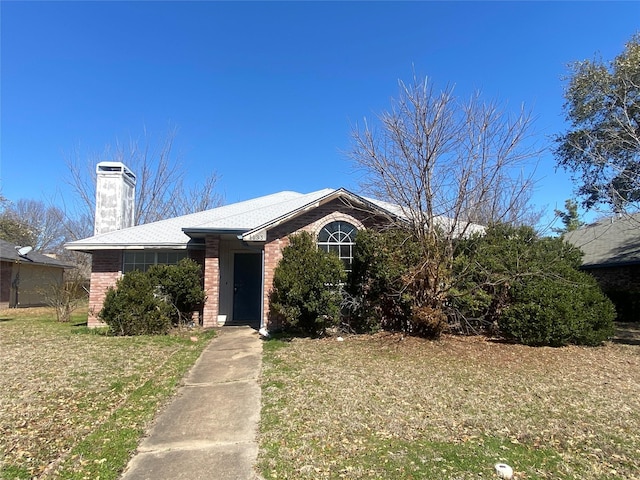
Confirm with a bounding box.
[564,213,640,321]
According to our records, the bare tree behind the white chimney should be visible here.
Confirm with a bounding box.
[66,124,223,238]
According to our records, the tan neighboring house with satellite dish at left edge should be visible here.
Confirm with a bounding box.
[0,240,70,308]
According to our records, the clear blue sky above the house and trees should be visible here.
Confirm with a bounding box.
[0,0,640,227]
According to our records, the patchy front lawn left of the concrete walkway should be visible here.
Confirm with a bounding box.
[0,308,213,480]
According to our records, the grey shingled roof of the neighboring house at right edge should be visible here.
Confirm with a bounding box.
[563,213,640,268]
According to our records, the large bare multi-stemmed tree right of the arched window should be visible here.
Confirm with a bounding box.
[349,76,540,309]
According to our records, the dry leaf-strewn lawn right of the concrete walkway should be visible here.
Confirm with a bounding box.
[259,334,640,480]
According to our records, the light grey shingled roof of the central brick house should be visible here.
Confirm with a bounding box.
[65,188,484,251]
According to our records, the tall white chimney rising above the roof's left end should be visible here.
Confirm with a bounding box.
[94,162,136,235]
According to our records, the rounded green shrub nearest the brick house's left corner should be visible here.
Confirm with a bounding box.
[98,271,172,335]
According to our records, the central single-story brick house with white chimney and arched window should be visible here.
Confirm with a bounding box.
[65,162,479,328]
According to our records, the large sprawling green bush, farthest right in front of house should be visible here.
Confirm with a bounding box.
[450,224,615,346]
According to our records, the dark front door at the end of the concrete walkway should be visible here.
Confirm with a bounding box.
[232,253,262,328]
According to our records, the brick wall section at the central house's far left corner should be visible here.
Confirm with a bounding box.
[87,250,122,327]
